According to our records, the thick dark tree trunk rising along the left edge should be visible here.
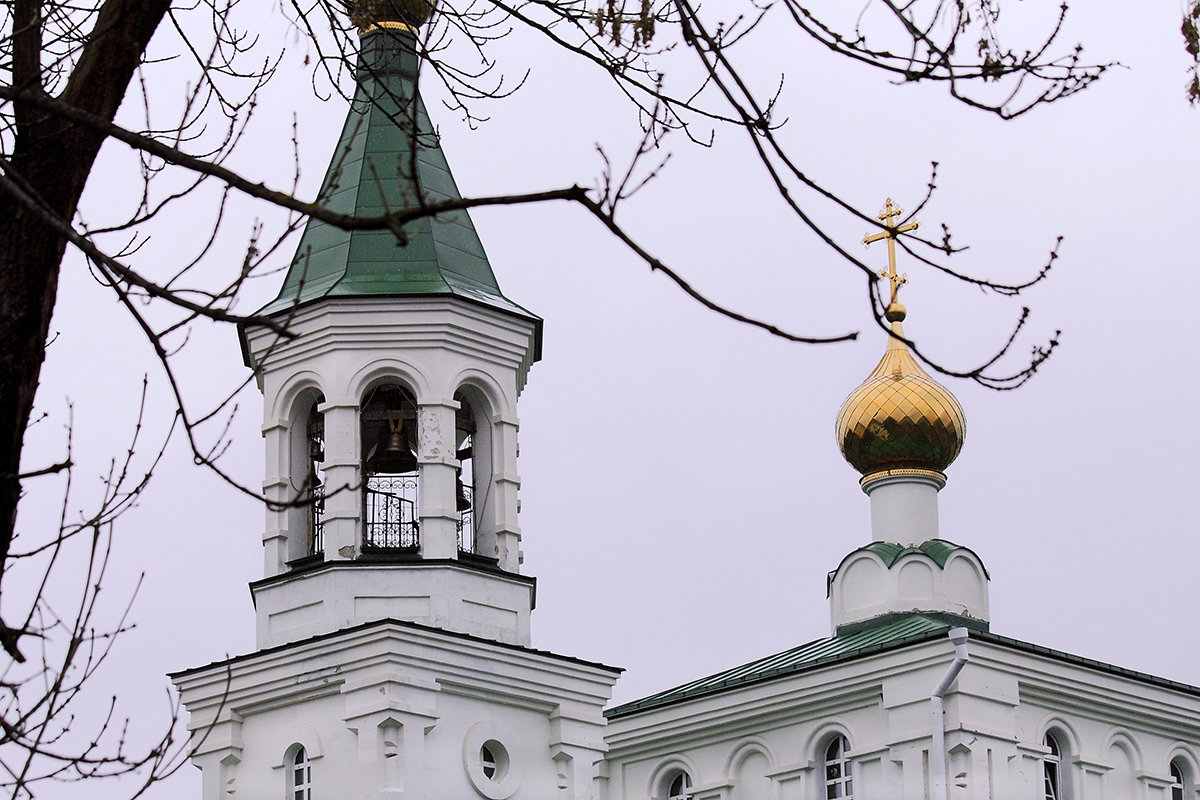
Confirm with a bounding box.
[0,0,170,655]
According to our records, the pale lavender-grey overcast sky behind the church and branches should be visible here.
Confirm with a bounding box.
[11,0,1200,799]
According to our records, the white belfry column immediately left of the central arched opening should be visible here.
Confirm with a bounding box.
[317,403,362,561]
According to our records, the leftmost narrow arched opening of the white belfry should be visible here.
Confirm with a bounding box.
[284,389,325,563]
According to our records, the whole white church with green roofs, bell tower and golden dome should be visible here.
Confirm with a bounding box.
[172,4,1200,800]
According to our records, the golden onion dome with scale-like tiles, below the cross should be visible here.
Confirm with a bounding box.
[836,303,966,482]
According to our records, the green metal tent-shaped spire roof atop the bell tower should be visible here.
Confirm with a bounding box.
[258,29,541,331]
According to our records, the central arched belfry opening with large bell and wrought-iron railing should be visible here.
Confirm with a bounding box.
[360,384,420,551]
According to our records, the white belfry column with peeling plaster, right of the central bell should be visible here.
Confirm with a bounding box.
[416,399,458,559]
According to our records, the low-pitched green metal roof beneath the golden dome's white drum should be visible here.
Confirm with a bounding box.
[605,614,1200,720]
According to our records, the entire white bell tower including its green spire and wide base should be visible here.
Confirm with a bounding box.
[172,14,619,800]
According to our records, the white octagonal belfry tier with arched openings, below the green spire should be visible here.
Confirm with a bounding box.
[246,289,538,648]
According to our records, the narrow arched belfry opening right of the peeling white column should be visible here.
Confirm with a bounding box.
[454,386,496,558]
